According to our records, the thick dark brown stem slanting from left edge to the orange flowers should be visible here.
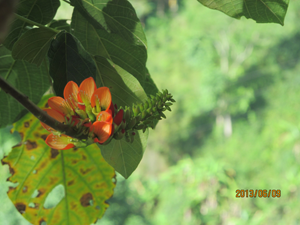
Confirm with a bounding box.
[0,77,88,139]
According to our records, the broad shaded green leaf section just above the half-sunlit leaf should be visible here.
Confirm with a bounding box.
[71,9,147,84]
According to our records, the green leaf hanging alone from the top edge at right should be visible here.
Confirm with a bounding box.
[198,0,289,26]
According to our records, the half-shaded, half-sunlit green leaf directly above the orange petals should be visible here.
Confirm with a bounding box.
[95,56,147,107]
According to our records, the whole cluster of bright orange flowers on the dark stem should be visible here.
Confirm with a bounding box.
[42,77,123,150]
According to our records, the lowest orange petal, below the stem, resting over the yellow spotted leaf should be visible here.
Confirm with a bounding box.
[45,134,75,150]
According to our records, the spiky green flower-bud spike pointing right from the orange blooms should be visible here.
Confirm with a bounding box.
[115,90,175,143]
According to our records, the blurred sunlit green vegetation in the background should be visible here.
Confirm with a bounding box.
[0,0,300,225]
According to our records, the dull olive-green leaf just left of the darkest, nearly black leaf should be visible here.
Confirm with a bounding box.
[12,28,56,66]
